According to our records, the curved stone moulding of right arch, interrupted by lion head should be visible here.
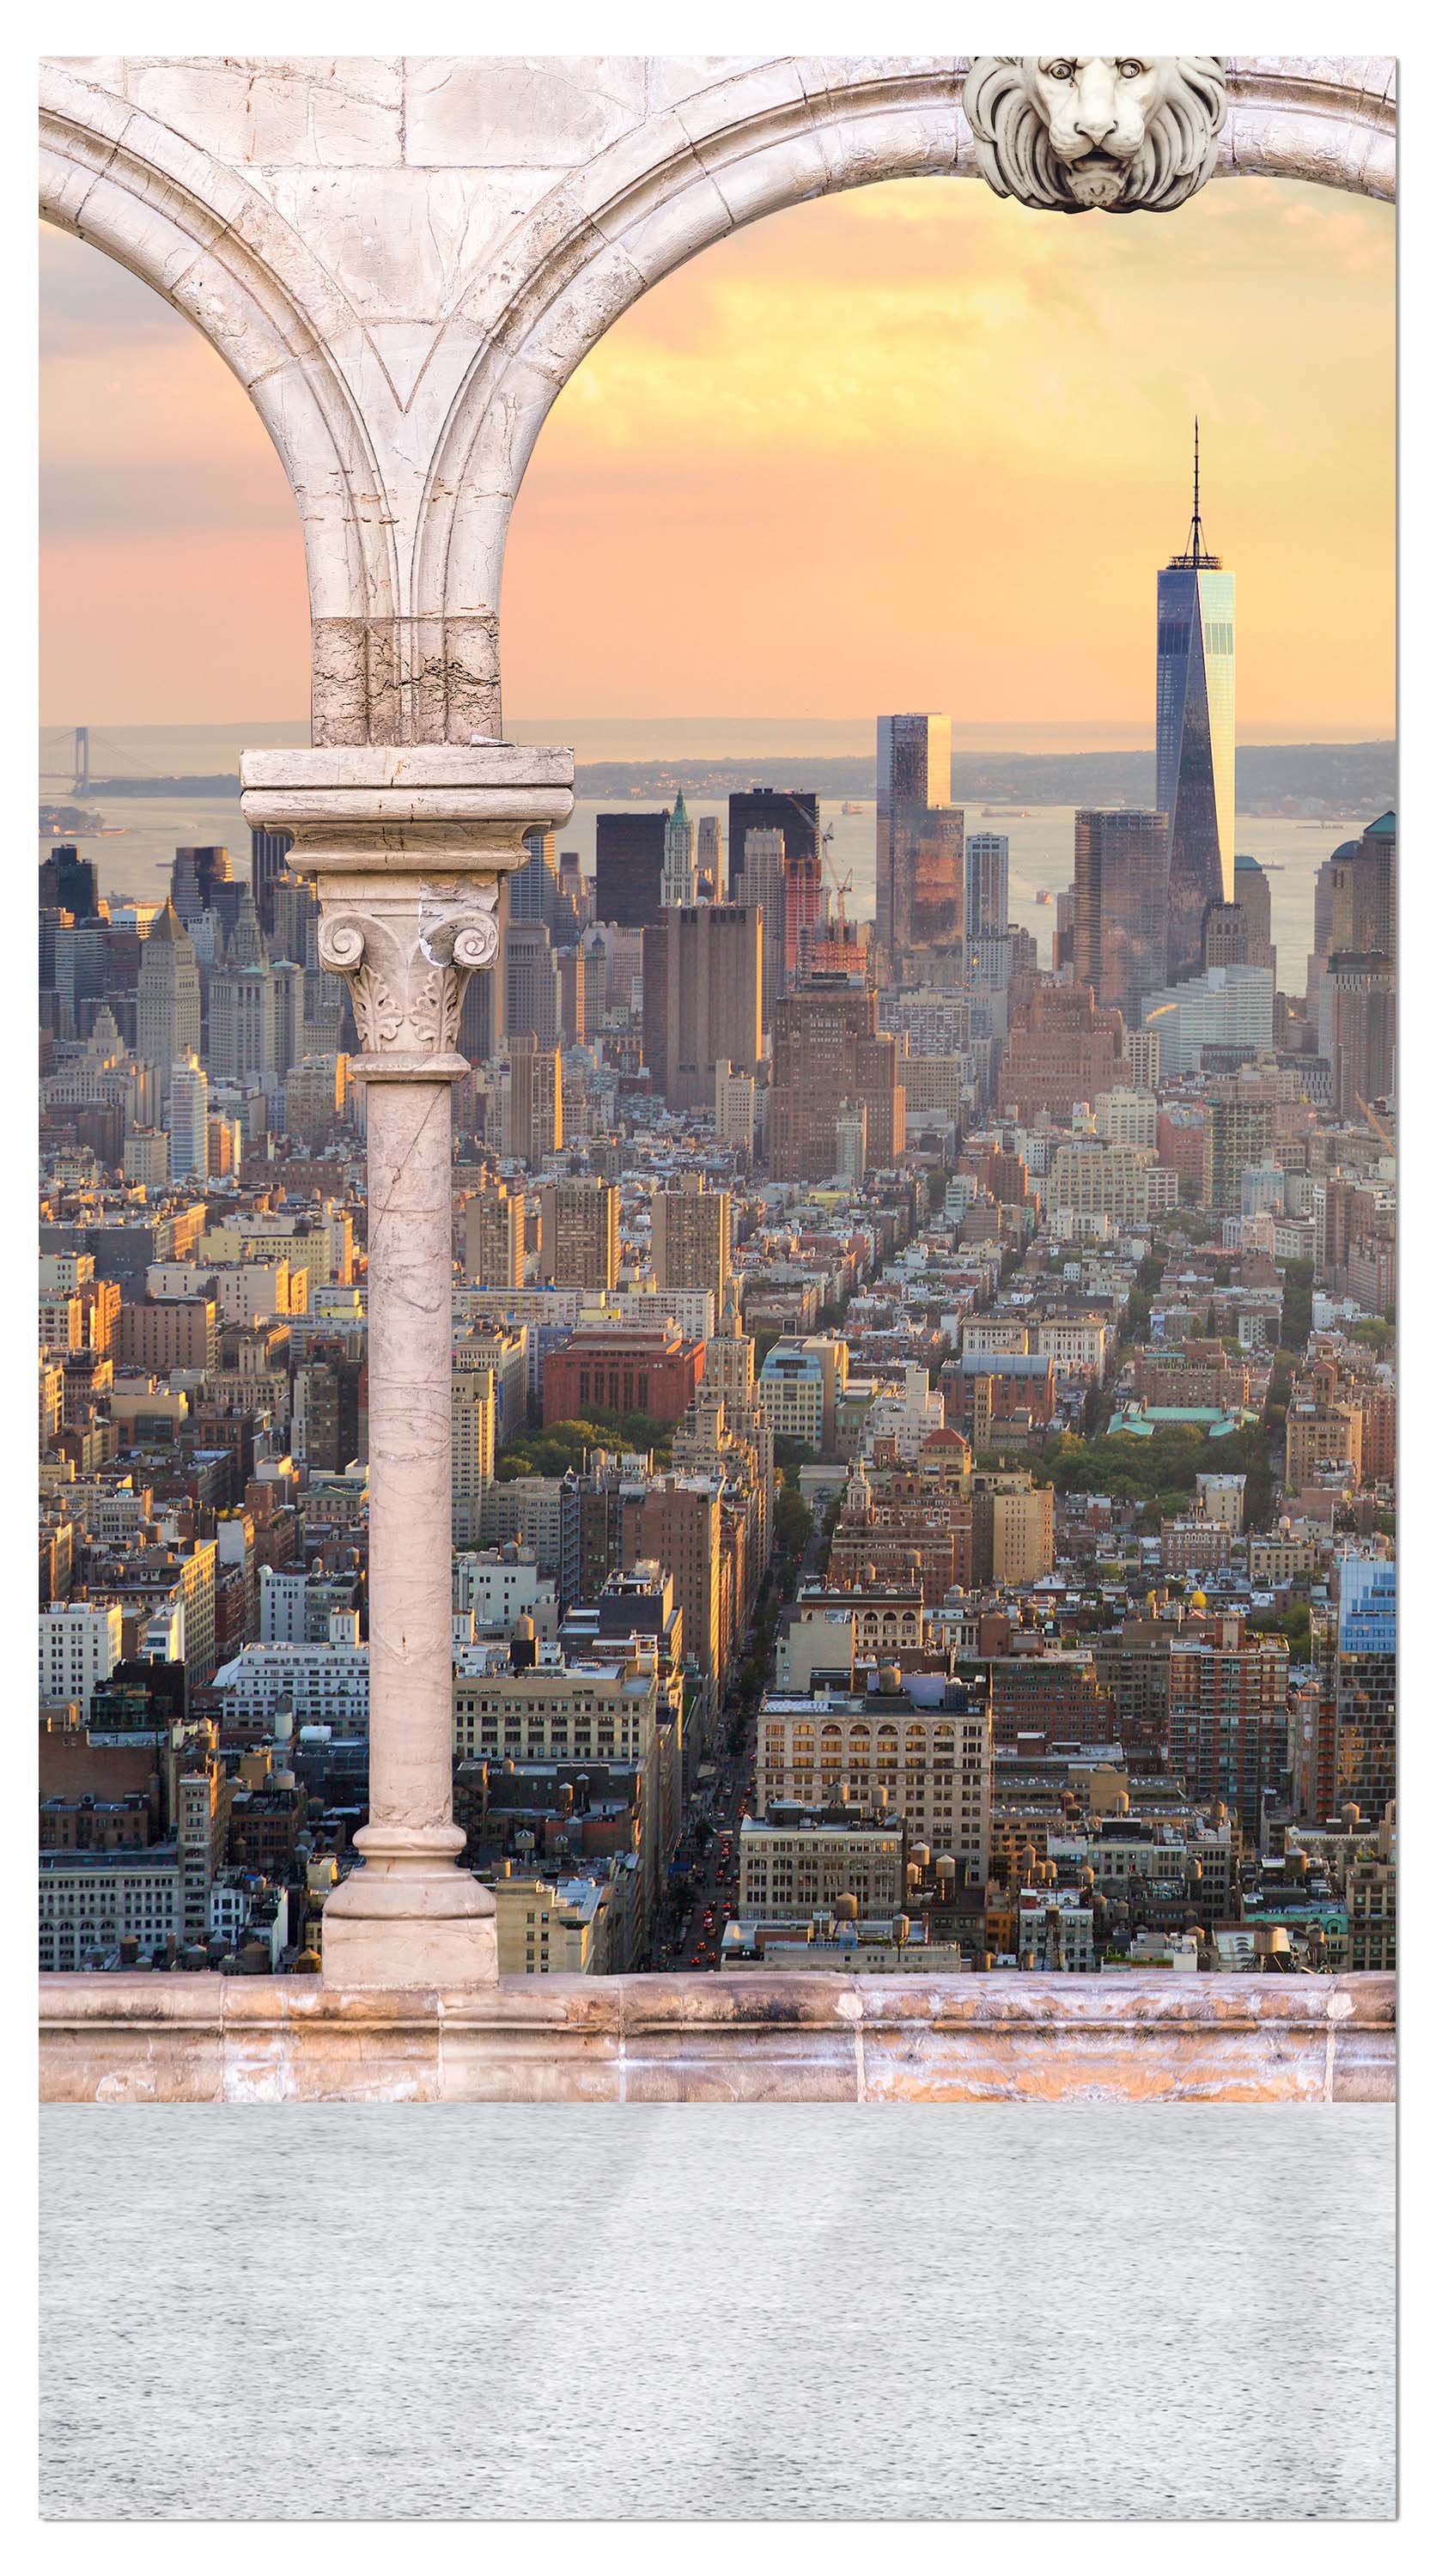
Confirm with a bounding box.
[415,57,1395,739]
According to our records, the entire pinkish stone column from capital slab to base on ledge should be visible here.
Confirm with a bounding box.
[240,742,572,1986]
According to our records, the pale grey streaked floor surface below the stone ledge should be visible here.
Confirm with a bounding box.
[41,2105,1395,2514]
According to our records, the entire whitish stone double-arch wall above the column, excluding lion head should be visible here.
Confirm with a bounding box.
[41,54,1395,747]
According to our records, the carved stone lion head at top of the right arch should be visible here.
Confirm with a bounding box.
[962,54,1227,214]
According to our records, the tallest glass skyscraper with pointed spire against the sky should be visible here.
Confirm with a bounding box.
[1158,422,1238,981]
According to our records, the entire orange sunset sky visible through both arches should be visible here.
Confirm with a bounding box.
[41,180,1395,742]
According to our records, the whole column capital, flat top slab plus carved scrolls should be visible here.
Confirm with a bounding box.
[240,742,572,1082]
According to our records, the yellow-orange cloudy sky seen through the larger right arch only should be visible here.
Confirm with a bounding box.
[502,180,1395,724]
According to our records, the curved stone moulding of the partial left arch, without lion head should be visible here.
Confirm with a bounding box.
[39,64,402,742]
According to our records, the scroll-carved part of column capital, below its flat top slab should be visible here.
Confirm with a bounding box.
[319,878,497,1056]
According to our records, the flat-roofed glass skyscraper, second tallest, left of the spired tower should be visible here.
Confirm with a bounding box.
[874,716,967,969]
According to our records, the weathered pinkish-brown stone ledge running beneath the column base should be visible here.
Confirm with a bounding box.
[39,1971,1395,2105]
